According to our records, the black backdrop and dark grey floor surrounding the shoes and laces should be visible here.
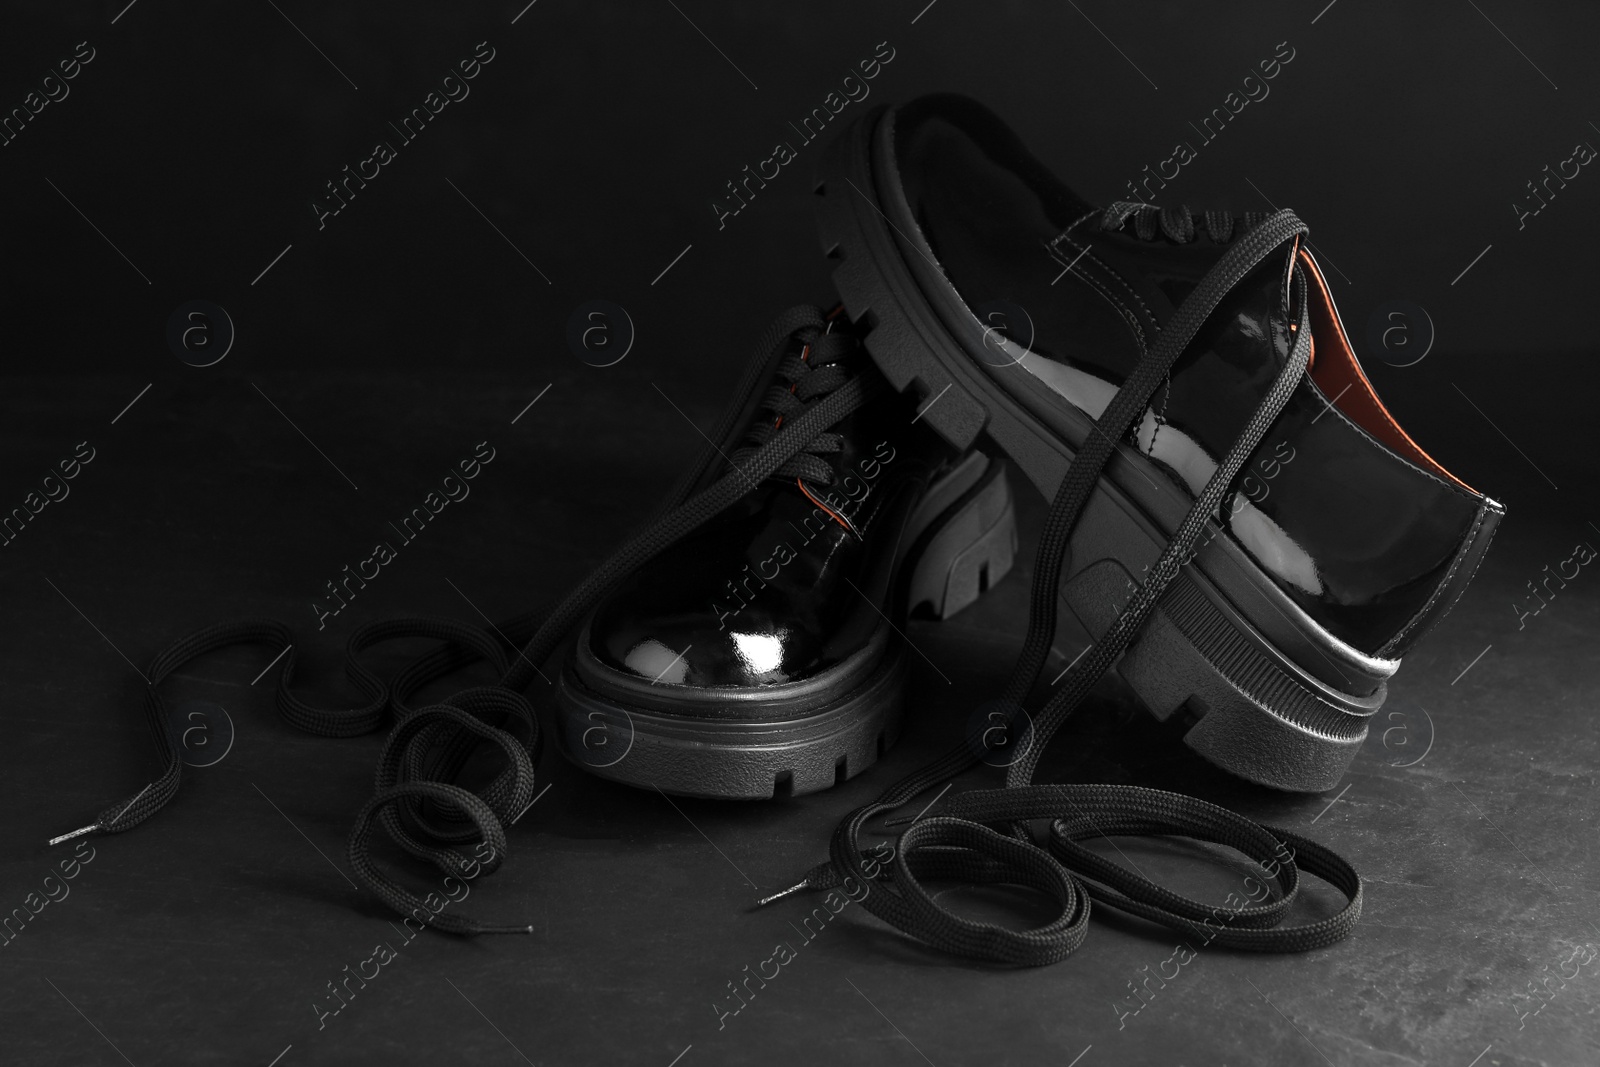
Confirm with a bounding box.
[0,0,1600,1067]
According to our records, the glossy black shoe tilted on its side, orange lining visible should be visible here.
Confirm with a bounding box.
[818,96,1504,790]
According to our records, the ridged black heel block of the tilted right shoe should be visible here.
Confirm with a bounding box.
[1061,560,1387,792]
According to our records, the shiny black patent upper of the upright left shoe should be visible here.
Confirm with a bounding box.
[578,323,950,703]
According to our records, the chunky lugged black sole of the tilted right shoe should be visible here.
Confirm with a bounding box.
[816,110,1398,792]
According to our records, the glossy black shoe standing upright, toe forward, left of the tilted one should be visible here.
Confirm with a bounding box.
[558,307,1016,798]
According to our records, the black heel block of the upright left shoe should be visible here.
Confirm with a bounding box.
[906,453,1016,619]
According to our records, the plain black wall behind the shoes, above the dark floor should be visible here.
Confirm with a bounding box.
[0,0,1600,506]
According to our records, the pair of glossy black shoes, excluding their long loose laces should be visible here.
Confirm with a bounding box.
[560,96,1502,798]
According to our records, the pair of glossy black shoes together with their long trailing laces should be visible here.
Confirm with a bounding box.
[75,96,1502,965]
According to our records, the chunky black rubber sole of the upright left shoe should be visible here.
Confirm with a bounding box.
[555,453,1016,800]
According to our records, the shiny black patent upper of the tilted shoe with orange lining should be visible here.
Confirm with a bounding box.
[891,96,1502,657]
